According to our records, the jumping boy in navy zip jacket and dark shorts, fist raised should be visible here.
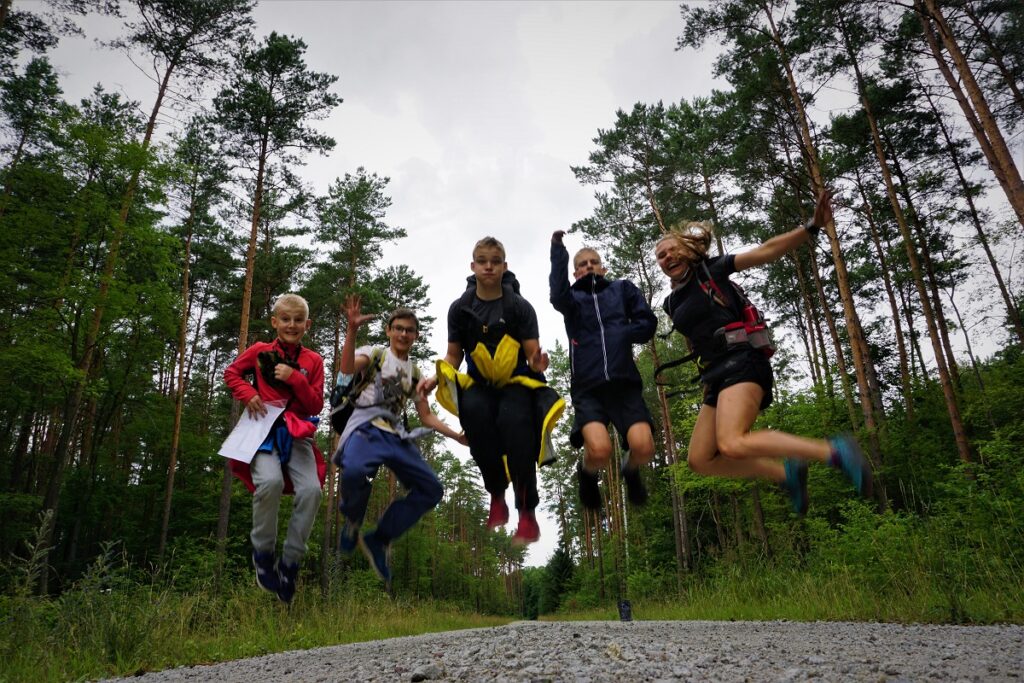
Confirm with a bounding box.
[548,230,657,510]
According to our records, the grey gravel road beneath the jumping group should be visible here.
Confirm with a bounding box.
[103,622,1024,683]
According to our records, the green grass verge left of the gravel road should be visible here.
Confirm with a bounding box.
[0,584,510,681]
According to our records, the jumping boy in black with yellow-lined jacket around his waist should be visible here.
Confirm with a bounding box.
[421,238,565,545]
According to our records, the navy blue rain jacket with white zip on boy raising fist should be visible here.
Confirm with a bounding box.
[548,244,657,392]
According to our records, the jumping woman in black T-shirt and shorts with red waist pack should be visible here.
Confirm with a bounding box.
[654,191,871,514]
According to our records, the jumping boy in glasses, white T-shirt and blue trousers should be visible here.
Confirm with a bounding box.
[335,296,466,590]
